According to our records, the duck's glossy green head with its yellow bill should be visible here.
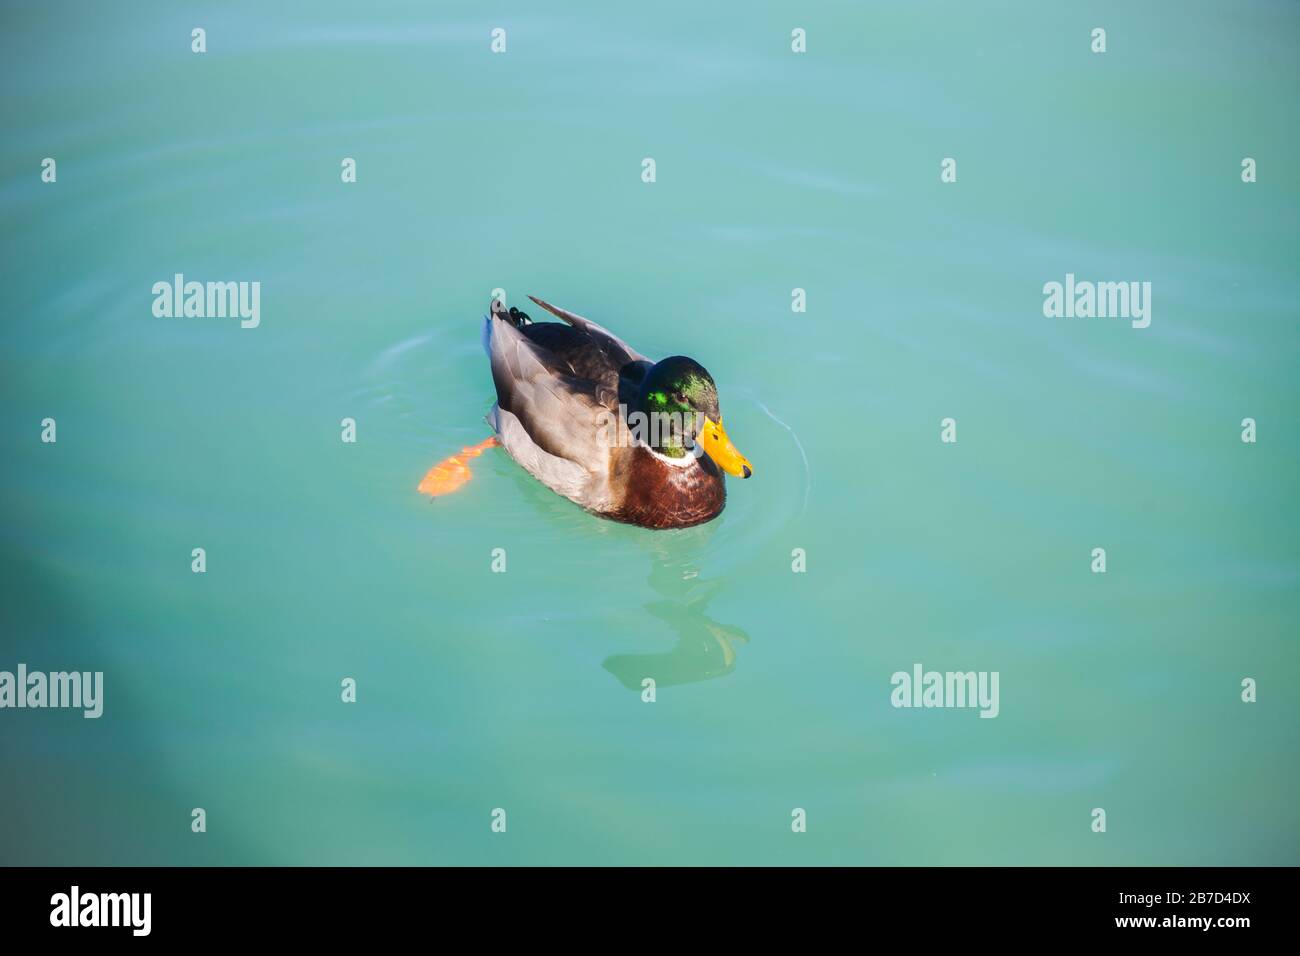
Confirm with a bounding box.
[636,355,754,477]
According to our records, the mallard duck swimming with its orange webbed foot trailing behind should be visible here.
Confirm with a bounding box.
[419,295,754,529]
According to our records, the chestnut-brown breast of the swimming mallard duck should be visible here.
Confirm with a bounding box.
[606,446,727,528]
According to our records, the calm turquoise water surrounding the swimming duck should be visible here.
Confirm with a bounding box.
[0,1,1300,865]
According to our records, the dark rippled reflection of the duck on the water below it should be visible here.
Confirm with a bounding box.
[603,532,749,692]
